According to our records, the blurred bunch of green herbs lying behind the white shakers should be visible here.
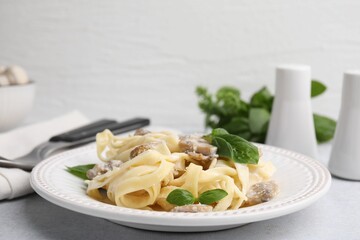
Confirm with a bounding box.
[196,80,336,145]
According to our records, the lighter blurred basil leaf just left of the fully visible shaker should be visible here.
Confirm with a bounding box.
[249,108,270,134]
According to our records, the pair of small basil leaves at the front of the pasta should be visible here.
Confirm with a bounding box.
[166,188,228,206]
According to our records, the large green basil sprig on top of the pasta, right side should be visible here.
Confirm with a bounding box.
[204,128,259,164]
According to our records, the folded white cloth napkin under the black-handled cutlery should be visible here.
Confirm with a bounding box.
[0,111,89,200]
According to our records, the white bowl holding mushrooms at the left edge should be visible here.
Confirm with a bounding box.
[0,82,35,132]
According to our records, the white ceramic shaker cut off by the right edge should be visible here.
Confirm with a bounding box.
[329,71,360,180]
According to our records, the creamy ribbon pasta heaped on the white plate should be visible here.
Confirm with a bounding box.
[86,130,275,211]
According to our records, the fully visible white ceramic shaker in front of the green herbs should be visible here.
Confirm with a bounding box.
[266,65,317,158]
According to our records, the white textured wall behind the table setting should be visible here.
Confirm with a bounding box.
[0,0,360,130]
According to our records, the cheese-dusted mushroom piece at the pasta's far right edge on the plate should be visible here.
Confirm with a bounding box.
[246,181,279,206]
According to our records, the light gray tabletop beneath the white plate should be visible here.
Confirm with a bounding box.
[0,131,360,240]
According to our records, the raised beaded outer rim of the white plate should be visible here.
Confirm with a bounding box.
[30,144,331,232]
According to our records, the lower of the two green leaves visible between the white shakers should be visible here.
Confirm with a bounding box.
[314,114,336,143]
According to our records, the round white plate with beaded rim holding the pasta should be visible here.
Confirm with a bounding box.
[31,145,331,232]
